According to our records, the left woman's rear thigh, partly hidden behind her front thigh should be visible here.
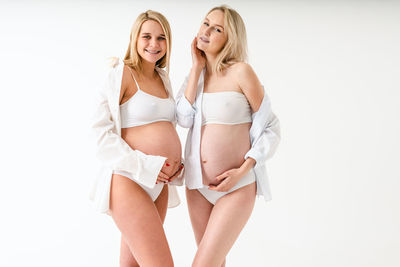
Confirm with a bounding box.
[119,185,168,267]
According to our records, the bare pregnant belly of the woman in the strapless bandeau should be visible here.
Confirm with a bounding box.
[200,123,251,185]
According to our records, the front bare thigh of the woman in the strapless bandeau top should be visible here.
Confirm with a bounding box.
[192,183,256,267]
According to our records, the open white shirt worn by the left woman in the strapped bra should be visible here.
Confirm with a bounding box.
[89,59,183,214]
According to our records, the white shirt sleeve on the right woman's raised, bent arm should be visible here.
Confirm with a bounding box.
[176,77,196,128]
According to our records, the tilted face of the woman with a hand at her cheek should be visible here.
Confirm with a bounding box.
[197,10,227,54]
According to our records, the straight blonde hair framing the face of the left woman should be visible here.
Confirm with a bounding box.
[124,10,171,72]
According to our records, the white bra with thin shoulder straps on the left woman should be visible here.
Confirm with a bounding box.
[119,68,176,128]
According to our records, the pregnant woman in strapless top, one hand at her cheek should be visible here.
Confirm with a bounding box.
[177,6,280,267]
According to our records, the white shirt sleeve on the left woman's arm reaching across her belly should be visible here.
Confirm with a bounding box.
[92,70,166,188]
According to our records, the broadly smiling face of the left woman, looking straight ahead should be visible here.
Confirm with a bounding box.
[136,20,167,63]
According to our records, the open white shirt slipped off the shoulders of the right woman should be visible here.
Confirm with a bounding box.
[176,70,280,201]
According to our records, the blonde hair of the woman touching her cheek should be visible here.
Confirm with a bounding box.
[206,5,247,72]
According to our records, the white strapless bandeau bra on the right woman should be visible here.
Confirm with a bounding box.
[201,91,252,125]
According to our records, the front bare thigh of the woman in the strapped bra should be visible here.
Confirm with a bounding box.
[110,174,173,266]
